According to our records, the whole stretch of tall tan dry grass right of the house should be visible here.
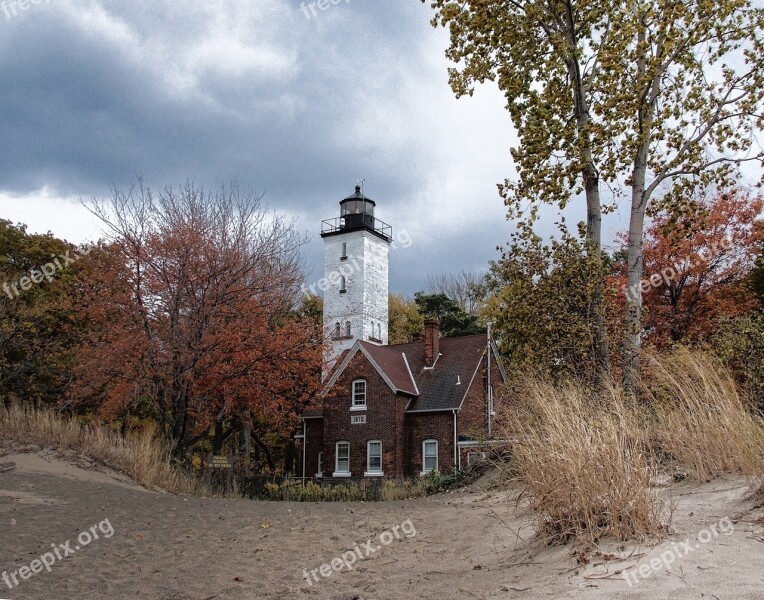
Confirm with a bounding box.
[500,349,764,543]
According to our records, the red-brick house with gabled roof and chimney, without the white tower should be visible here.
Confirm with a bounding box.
[302,320,505,478]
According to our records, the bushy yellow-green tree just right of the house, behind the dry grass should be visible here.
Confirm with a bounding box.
[483,227,617,383]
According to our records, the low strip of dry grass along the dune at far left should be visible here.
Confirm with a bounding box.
[0,404,194,493]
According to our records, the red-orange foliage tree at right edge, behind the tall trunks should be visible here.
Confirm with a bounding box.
[625,190,764,347]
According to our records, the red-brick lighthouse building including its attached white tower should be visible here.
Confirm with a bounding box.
[296,185,505,478]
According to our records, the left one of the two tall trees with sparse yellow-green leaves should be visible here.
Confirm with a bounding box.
[422,0,609,371]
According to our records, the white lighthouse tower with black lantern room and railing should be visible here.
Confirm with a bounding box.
[321,185,393,366]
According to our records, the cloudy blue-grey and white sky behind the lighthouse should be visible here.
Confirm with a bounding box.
[0,0,724,294]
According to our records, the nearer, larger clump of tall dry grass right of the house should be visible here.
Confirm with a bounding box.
[510,381,667,543]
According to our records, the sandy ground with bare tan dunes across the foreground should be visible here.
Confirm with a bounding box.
[0,454,764,600]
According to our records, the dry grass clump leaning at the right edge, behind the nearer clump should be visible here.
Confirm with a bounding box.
[643,349,764,481]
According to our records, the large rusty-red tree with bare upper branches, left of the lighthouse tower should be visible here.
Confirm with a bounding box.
[75,182,323,466]
